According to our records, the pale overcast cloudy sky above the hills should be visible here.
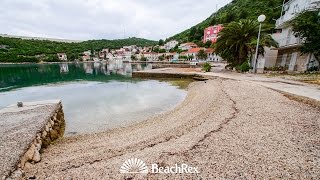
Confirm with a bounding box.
[0,0,231,40]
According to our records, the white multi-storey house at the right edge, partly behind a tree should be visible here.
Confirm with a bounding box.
[275,0,320,72]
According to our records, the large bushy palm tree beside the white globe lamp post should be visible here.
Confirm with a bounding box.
[215,19,276,66]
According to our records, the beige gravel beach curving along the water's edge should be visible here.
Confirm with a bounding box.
[25,79,320,179]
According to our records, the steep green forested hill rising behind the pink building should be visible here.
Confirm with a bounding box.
[168,0,283,43]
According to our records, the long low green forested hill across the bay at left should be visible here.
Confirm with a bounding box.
[0,36,157,62]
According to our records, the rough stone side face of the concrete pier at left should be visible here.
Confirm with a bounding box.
[11,102,65,179]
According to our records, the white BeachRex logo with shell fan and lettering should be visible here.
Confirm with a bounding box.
[120,158,199,174]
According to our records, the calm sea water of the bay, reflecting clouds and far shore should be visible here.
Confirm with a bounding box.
[0,62,186,135]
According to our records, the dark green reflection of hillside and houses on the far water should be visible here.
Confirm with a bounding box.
[0,60,152,92]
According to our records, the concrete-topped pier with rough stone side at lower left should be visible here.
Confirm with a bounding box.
[0,100,65,179]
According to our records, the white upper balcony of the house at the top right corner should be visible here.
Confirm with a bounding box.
[276,0,320,28]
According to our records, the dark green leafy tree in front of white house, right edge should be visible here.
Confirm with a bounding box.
[291,11,320,60]
